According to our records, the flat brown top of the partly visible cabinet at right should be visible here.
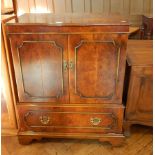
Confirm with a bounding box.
[127,40,153,66]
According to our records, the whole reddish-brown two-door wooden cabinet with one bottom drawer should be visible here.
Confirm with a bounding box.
[6,14,129,145]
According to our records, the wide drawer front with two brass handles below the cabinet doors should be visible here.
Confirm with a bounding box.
[18,107,123,133]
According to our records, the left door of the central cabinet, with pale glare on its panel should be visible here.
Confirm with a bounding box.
[10,34,69,103]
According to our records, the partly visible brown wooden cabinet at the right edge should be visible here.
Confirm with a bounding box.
[124,40,153,135]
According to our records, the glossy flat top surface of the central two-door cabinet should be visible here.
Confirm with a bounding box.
[7,13,129,26]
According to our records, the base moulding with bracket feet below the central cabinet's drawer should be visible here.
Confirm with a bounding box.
[18,132,125,147]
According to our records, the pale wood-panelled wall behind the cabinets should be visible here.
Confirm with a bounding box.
[17,0,153,15]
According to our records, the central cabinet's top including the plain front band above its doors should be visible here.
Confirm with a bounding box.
[7,14,129,34]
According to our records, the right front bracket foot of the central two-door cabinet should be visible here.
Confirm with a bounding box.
[99,137,124,147]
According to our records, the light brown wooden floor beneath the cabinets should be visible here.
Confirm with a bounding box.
[2,126,153,155]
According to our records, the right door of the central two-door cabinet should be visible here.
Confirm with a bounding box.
[69,34,127,103]
